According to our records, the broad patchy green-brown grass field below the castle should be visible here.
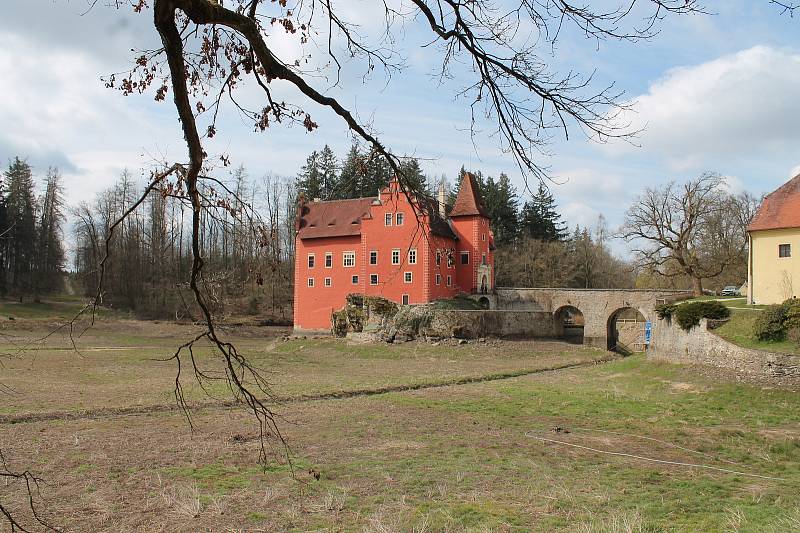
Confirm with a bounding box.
[0,310,800,532]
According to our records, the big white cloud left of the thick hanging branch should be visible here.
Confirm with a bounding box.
[0,32,180,203]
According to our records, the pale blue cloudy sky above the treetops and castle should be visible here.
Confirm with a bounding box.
[0,0,800,254]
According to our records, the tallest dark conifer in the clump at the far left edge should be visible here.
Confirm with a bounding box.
[6,157,36,301]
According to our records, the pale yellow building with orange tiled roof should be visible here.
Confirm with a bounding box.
[747,175,800,304]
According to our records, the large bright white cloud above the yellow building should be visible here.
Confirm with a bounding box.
[611,46,800,165]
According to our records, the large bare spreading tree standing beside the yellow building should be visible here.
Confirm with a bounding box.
[620,173,755,296]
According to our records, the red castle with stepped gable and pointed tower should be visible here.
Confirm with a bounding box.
[294,174,494,331]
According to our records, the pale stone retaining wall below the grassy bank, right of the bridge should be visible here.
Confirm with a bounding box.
[647,319,800,383]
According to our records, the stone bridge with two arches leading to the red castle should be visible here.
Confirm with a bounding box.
[472,287,691,349]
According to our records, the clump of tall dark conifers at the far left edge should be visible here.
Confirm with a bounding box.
[0,157,66,302]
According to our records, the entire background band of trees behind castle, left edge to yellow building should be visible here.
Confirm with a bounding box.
[0,152,759,318]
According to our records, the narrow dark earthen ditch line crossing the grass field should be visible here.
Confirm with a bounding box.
[0,353,620,425]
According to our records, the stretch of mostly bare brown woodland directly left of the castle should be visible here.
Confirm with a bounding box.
[72,167,296,320]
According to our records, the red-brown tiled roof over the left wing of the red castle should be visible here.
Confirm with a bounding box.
[297,198,375,239]
